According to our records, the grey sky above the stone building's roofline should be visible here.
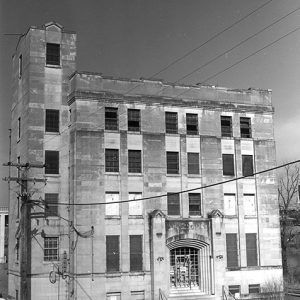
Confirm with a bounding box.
[0,0,300,206]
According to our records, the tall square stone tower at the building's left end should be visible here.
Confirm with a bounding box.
[9,22,76,300]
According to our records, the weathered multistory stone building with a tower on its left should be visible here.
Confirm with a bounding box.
[9,23,282,300]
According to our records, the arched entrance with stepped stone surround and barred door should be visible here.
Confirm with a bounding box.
[167,239,212,294]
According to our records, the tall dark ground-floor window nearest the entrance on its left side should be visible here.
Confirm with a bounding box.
[129,235,143,272]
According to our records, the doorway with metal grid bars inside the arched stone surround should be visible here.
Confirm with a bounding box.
[170,247,200,288]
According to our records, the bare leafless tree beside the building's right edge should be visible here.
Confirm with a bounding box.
[278,164,300,274]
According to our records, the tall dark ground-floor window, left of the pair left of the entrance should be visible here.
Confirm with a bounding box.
[106,235,120,274]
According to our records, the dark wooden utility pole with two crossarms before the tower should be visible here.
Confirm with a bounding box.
[3,162,46,300]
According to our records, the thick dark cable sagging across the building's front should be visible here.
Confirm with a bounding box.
[48,159,300,206]
